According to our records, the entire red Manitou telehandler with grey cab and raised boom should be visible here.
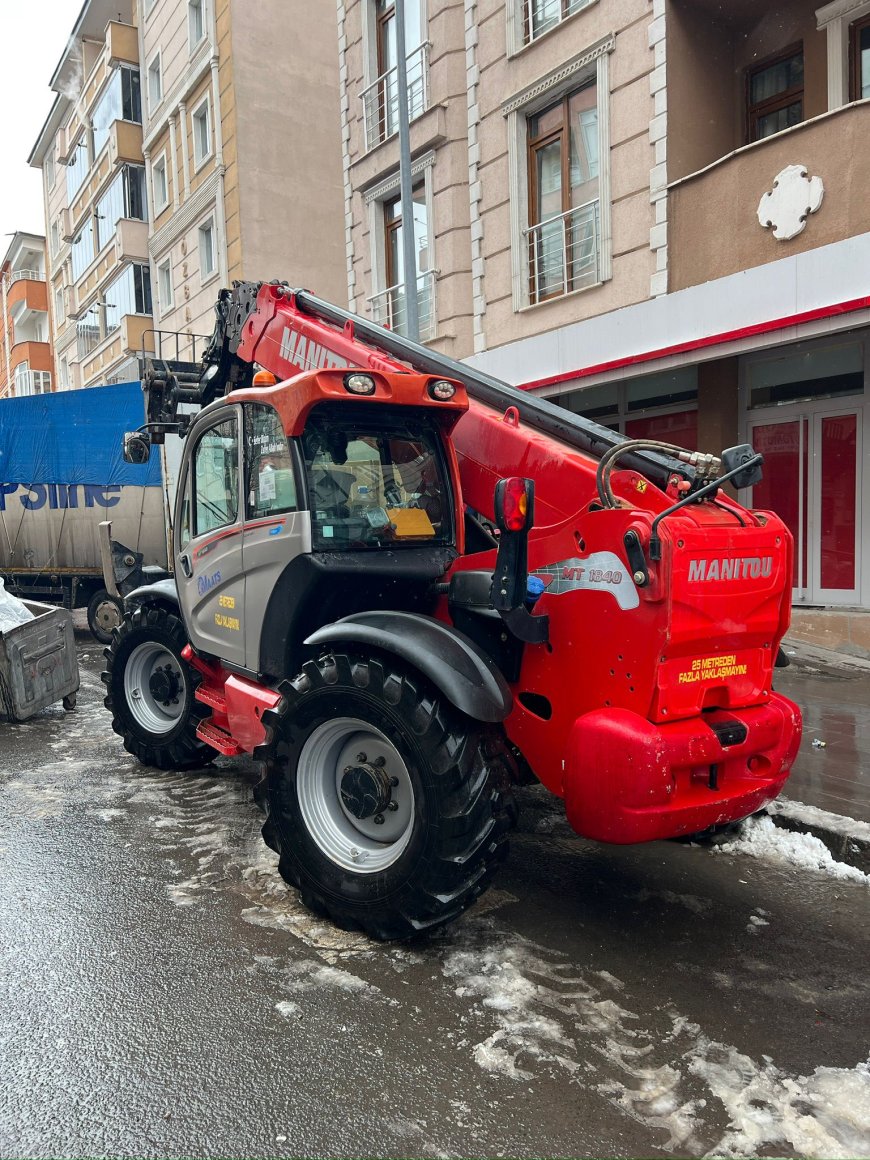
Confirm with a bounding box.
[103,283,800,938]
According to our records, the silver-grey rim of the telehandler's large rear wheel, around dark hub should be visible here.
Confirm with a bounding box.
[296,717,414,873]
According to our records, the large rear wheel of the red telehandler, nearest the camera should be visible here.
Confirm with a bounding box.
[256,654,510,938]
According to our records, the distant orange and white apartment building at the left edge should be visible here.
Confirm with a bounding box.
[0,232,53,399]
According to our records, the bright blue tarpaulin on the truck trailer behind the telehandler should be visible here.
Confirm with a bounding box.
[0,383,160,487]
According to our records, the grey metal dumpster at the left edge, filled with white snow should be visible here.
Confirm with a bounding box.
[0,600,79,722]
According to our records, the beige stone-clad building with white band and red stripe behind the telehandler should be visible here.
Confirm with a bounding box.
[338,0,870,654]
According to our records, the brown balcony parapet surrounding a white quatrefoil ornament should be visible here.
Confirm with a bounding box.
[668,101,870,291]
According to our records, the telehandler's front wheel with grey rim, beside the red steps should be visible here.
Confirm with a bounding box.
[102,608,209,769]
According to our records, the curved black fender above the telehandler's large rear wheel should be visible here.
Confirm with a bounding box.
[305,612,513,723]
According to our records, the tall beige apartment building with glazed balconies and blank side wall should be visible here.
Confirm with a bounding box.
[30,0,345,389]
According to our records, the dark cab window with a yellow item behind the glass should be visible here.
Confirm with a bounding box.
[303,415,452,549]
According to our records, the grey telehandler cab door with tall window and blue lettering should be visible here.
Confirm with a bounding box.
[175,407,245,665]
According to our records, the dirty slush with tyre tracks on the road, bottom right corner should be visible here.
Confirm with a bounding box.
[442,915,870,1160]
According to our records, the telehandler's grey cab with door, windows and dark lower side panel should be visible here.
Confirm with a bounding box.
[175,376,466,676]
